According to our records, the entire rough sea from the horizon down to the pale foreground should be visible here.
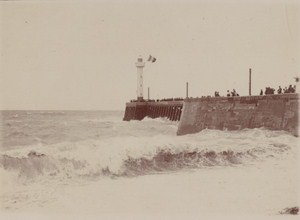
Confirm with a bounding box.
[0,111,299,216]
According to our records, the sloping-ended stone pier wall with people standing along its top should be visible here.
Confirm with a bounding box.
[177,93,299,136]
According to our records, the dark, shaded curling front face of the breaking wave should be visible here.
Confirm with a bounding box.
[0,150,253,178]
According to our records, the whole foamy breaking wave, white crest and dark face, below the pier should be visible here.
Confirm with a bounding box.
[0,129,297,180]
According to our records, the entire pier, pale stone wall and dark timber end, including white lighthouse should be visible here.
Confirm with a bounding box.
[123,58,299,136]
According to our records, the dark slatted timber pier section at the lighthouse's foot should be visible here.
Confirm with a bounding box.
[123,101,183,121]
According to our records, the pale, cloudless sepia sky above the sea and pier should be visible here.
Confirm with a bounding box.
[0,0,300,110]
